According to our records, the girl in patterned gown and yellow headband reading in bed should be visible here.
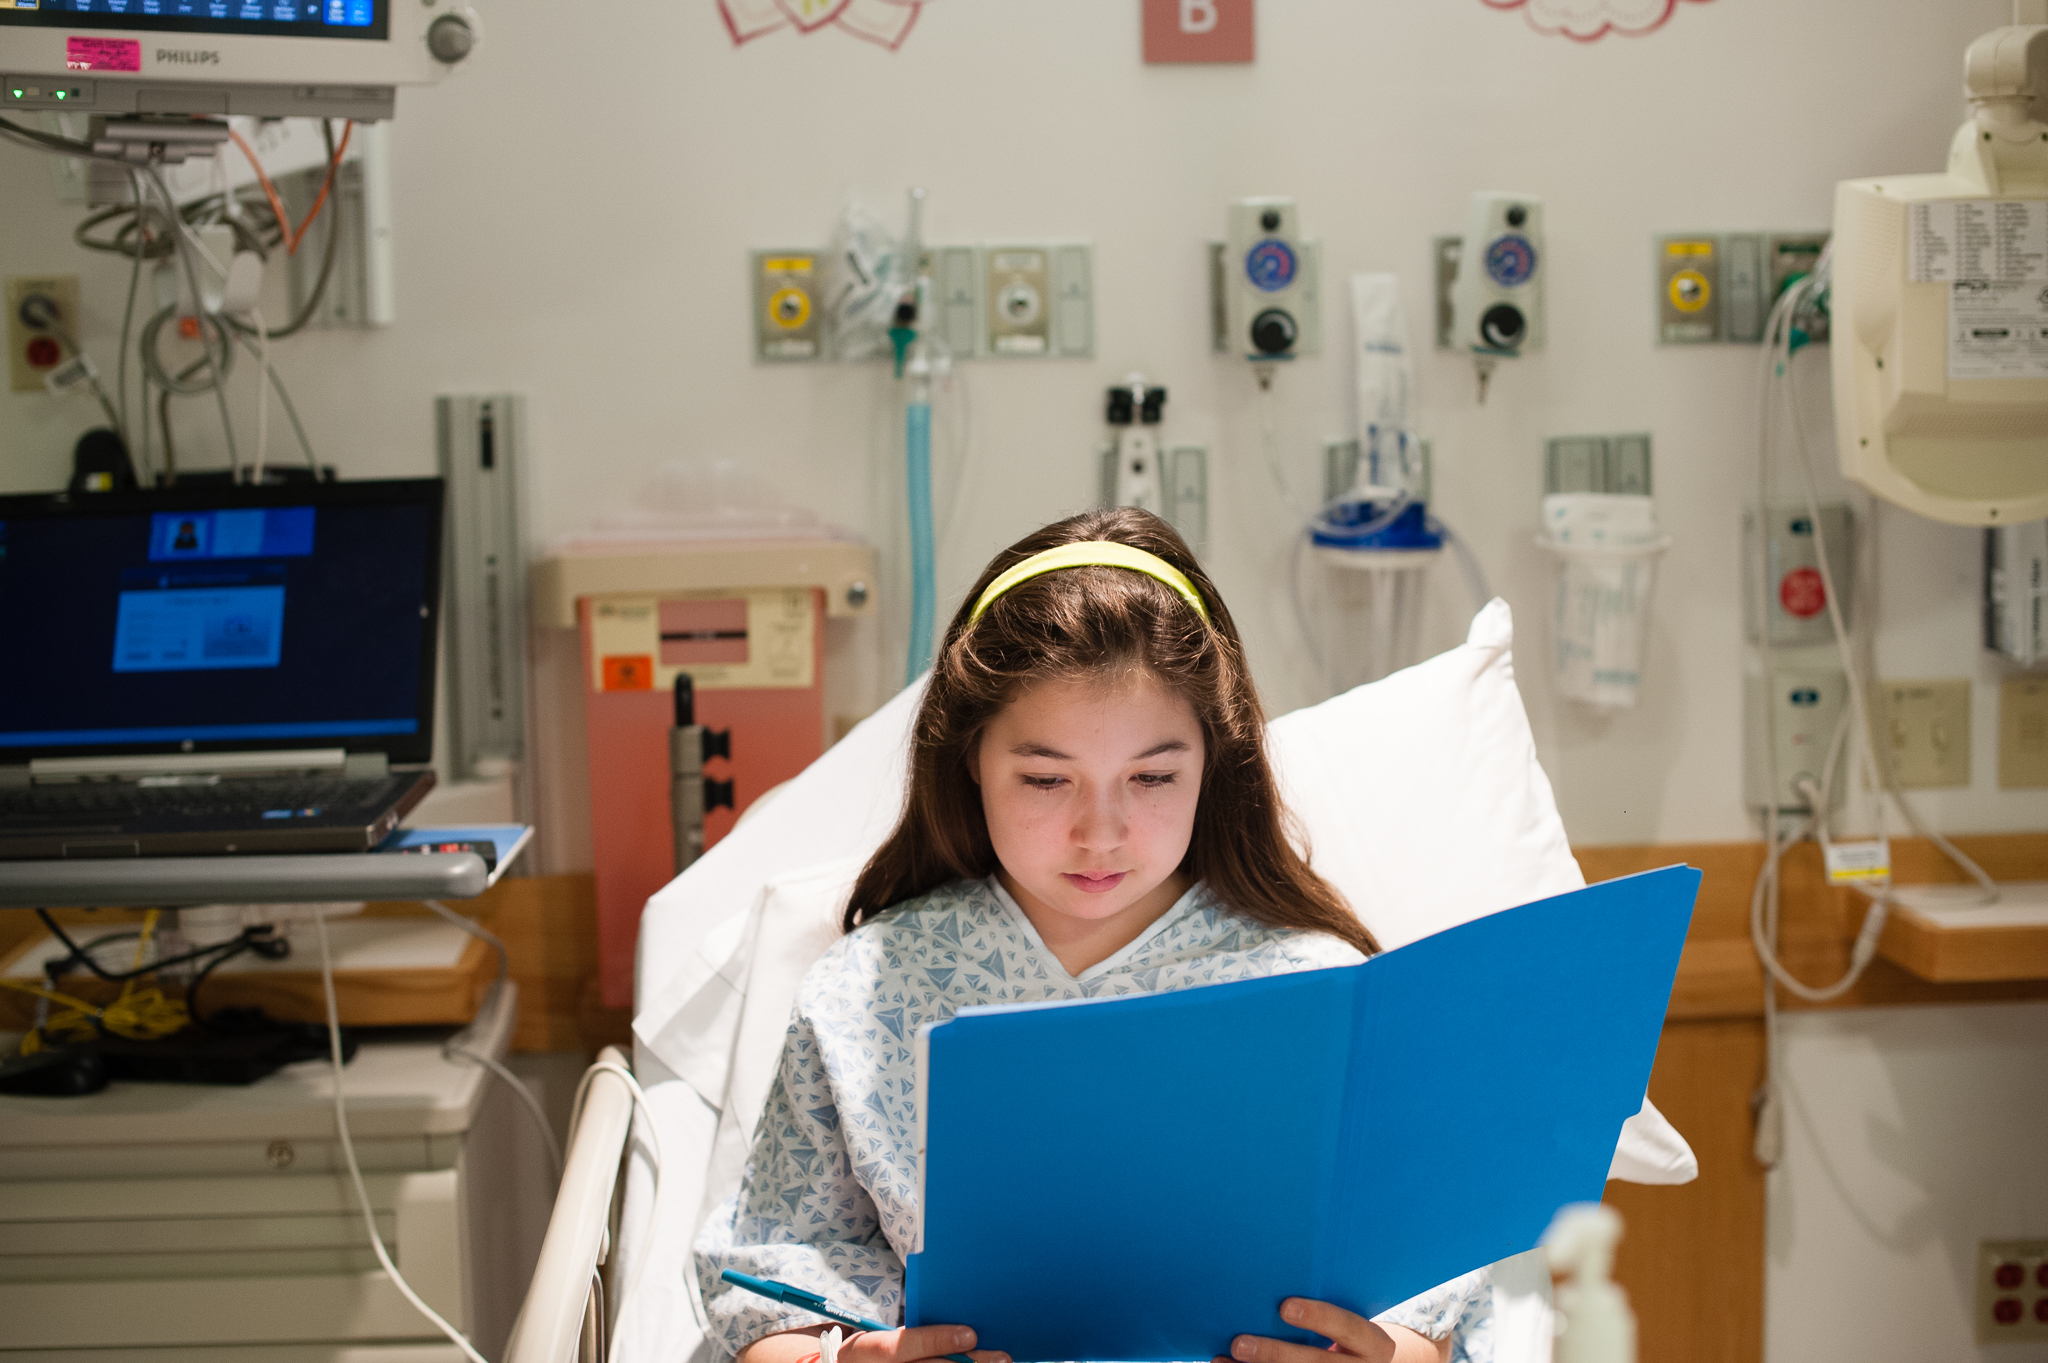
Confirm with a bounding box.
[696,508,1491,1363]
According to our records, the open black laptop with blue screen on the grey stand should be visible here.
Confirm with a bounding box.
[0,479,442,860]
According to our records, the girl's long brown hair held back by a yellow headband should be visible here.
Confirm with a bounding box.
[844,508,1378,956]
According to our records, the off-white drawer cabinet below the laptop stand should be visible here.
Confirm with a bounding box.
[0,991,553,1363]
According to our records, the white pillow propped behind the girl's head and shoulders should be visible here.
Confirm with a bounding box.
[633,600,1698,1183]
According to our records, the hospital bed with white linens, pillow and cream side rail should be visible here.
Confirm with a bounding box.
[506,600,1698,1363]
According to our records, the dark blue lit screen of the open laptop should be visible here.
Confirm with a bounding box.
[0,479,440,761]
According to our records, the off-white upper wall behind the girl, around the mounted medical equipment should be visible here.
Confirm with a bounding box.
[0,0,2048,843]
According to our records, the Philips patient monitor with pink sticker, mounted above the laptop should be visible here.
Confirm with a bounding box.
[0,0,481,121]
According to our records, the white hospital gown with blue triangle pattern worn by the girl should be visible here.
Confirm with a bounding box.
[696,876,1493,1363]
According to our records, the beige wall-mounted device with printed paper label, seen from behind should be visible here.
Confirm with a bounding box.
[1831,25,2048,526]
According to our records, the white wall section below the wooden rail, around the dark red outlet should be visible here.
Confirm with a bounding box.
[1765,1003,2048,1363]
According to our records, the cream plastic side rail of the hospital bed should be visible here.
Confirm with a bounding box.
[504,1046,633,1363]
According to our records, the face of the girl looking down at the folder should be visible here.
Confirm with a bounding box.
[969,673,1202,953]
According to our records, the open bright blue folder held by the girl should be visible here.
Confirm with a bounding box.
[905,866,1700,1363]
